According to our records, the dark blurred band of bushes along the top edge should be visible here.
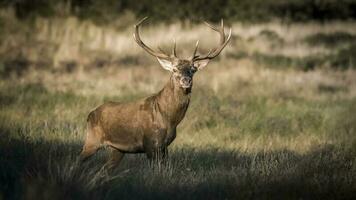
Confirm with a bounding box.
[0,0,356,24]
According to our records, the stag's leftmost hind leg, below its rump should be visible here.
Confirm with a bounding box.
[80,124,103,161]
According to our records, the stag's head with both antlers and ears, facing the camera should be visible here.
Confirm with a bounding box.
[134,17,231,89]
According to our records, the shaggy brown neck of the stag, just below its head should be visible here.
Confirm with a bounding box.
[157,76,191,126]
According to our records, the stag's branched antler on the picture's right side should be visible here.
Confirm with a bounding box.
[192,20,232,61]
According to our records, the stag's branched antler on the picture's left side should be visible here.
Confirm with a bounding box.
[133,17,176,60]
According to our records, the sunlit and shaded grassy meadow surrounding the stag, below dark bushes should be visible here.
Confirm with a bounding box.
[0,10,356,199]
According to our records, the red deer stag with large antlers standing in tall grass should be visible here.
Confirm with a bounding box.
[81,17,231,168]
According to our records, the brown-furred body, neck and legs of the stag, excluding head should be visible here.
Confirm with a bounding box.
[81,72,191,168]
